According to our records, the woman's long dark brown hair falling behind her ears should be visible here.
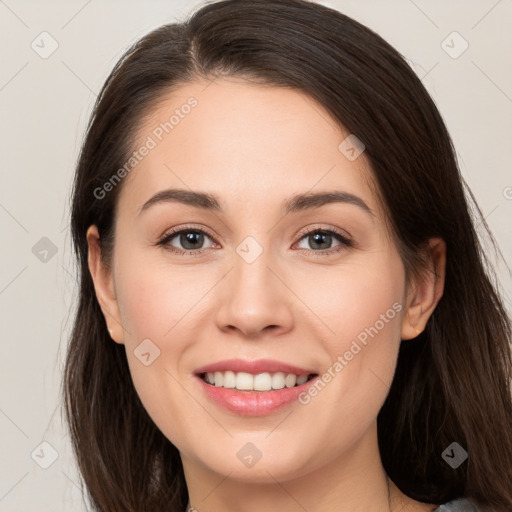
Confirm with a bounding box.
[63,0,512,512]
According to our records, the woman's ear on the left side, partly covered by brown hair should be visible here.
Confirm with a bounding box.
[86,225,124,344]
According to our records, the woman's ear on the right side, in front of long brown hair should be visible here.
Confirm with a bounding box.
[402,238,446,340]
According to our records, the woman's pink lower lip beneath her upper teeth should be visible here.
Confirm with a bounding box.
[197,376,318,416]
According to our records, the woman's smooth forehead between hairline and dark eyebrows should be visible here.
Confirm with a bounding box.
[116,78,377,217]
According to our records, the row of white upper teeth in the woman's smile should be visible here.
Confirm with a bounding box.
[203,371,308,391]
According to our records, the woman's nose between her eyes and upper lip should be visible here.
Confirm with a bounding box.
[216,251,297,340]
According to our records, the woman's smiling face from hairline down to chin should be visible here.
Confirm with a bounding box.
[89,79,432,482]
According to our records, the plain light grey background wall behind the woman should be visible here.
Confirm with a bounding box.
[0,0,512,512]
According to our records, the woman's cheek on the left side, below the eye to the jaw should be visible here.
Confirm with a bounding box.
[112,255,215,446]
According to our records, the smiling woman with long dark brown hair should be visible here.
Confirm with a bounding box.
[64,0,512,512]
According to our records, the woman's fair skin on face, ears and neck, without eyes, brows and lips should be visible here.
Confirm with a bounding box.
[87,78,446,512]
